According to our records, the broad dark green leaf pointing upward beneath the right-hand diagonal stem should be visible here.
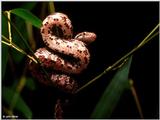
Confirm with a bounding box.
[91,57,132,119]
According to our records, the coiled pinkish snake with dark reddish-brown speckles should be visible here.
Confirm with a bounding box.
[30,12,96,93]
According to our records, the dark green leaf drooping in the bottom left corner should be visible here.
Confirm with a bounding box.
[2,87,32,118]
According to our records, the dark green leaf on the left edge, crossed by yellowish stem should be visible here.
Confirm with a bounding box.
[2,14,9,78]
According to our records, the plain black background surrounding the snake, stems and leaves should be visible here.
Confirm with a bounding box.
[2,2,159,118]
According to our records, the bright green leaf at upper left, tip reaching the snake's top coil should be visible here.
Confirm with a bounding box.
[11,8,42,28]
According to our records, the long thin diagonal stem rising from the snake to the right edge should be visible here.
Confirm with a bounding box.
[75,23,160,93]
